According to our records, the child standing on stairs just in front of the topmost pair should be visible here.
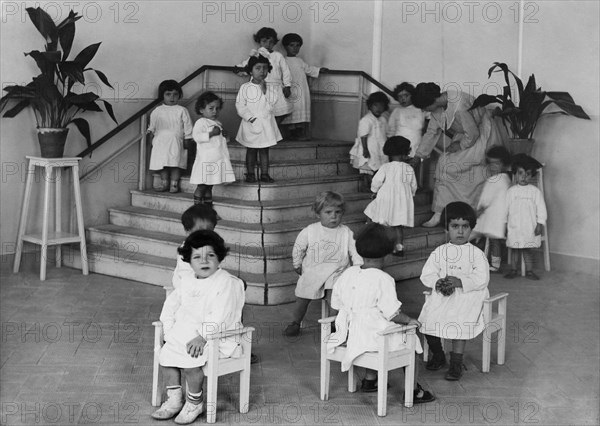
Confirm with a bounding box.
[235,53,281,183]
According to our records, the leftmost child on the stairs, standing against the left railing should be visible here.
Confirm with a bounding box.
[148,80,192,192]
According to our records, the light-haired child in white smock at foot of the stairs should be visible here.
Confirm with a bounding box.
[284,191,362,336]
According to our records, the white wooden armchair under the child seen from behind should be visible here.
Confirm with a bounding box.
[319,317,417,417]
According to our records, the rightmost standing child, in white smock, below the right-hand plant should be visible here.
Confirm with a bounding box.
[504,154,548,280]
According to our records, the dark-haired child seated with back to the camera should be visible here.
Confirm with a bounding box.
[327,223,435,404]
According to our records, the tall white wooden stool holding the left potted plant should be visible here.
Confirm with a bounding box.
[13,156,89,281]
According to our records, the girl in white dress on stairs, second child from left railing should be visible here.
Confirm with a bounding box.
[195,92,235,207]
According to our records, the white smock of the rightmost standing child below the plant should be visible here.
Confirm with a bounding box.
[506,185,548,249]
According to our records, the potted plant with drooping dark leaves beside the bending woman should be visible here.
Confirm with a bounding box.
[470,62,590,154]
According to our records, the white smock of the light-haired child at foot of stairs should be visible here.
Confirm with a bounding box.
[292,222,363,300]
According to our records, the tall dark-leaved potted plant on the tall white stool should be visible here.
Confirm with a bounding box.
[0,7,117,158]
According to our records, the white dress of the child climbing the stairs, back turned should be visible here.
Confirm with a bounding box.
[365,161,417,227]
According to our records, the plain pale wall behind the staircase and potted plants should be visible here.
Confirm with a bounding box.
[0,1,600,269]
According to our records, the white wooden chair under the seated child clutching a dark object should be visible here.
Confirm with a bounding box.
[423,291,508,373]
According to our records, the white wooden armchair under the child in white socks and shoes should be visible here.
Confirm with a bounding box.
[152,321,254,423]
